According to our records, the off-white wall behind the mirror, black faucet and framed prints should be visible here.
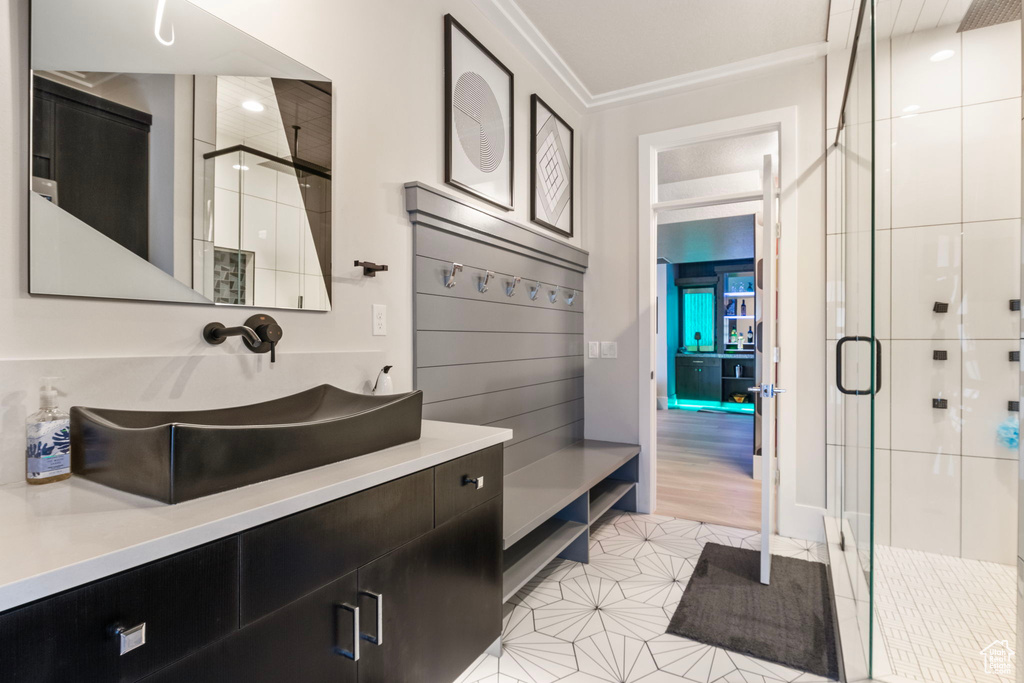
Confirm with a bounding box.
[0,0,589,483]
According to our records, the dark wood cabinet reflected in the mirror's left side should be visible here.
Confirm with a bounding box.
[32,76,153,259]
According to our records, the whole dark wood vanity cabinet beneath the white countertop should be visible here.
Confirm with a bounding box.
[0,446,502,683]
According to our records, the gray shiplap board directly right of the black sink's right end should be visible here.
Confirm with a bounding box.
[423,377,583,425]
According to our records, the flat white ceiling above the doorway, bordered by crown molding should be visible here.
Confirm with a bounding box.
[507,0,829,95]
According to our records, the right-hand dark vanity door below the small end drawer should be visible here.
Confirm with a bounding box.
[358,496,502,683]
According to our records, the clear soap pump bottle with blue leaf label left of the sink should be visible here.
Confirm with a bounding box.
[25,377,71,484]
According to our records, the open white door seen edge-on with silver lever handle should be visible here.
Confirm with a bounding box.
[751,155,784,584]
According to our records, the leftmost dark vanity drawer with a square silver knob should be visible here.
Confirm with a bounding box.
[0,537,239,683]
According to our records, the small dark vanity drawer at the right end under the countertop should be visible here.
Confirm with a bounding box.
[434,443,504,526]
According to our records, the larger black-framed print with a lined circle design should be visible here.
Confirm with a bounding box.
[444,14,515,211]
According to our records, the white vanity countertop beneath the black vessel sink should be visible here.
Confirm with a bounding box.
[0,420,512,611]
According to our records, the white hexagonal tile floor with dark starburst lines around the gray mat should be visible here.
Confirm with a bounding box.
[456,510,828,683]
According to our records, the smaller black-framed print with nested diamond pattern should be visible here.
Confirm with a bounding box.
[529,95,572,238]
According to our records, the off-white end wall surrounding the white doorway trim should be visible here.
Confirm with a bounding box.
[586,58,826,518]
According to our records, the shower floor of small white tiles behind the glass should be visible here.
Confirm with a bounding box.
[874,546,1017,683]
